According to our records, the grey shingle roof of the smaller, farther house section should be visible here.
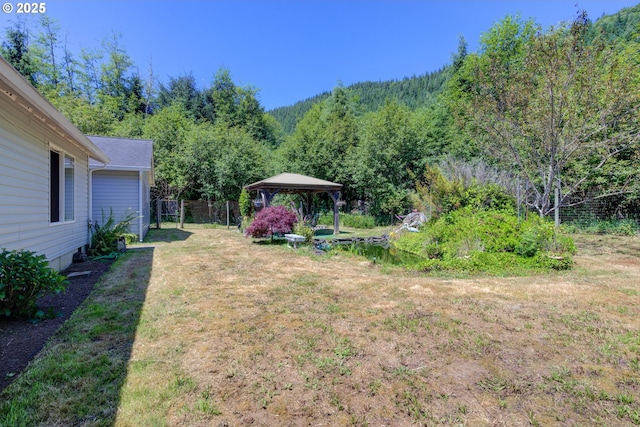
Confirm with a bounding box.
[87,135,153,172]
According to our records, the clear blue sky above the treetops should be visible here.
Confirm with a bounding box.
[0,0,638,110]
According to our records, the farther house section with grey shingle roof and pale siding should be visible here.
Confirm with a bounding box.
[88,136,154,241]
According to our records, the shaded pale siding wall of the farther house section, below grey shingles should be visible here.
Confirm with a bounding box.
[91,170,140,235]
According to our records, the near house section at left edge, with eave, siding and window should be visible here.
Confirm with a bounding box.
[0,57,109,270]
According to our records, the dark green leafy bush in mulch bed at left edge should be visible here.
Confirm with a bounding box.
[0,249,67,318]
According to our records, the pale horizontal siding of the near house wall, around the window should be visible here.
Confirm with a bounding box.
[0,96,88,269]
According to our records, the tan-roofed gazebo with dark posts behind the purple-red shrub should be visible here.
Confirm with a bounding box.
[245,172,342,234]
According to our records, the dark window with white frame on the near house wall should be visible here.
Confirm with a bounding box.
[49,150,75,223]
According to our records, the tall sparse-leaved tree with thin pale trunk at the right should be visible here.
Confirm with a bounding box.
[445,13,640,215]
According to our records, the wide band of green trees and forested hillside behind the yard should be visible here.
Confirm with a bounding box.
[0,6,640,221]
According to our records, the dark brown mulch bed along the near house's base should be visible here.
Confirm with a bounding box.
[0,260,113,391]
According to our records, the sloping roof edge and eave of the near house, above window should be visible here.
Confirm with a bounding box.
[0,57,109,163]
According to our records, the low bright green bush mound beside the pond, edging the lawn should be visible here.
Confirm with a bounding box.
[395,207,576,274]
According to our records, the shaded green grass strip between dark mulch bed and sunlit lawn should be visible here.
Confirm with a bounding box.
[0,250,153,426]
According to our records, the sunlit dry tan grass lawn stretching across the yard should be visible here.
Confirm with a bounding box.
[110,228,640,426]
